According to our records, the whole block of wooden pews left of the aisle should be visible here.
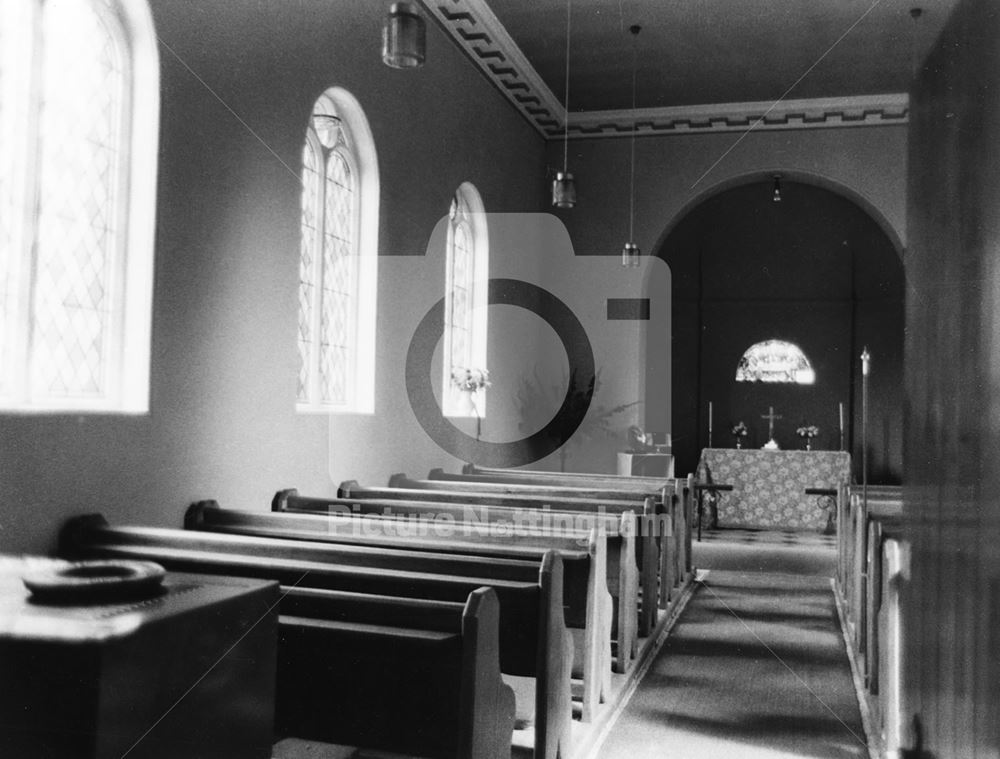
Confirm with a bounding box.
[60,466,693,759]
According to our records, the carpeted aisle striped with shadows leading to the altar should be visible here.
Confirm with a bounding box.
[598,544,868,759]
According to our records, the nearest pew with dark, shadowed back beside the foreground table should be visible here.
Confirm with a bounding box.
[275,588,516,759]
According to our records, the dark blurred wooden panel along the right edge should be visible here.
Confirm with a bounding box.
[904,0,1000,759]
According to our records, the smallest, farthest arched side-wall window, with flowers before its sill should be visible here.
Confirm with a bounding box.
[442,182,489,417]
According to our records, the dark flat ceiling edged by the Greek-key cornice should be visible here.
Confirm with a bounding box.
[424,0,957,135]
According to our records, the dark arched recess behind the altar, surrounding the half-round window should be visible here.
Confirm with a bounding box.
[647,175,904,482]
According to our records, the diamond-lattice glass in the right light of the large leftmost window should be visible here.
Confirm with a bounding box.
[32,0,125,397]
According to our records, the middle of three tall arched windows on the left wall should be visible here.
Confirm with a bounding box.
[297,87,379,413]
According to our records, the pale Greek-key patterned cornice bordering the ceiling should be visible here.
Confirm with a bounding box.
[421,0,909,139]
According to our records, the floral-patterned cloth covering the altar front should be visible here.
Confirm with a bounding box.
[698,448,851,532]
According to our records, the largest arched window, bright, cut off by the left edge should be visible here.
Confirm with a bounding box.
[0,0,159,413]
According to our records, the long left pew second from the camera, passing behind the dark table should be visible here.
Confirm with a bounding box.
[60,515,580,759]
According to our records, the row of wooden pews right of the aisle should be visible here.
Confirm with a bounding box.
[836,485,908,756]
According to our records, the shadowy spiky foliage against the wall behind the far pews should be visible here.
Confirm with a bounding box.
[516,368,641,472]
